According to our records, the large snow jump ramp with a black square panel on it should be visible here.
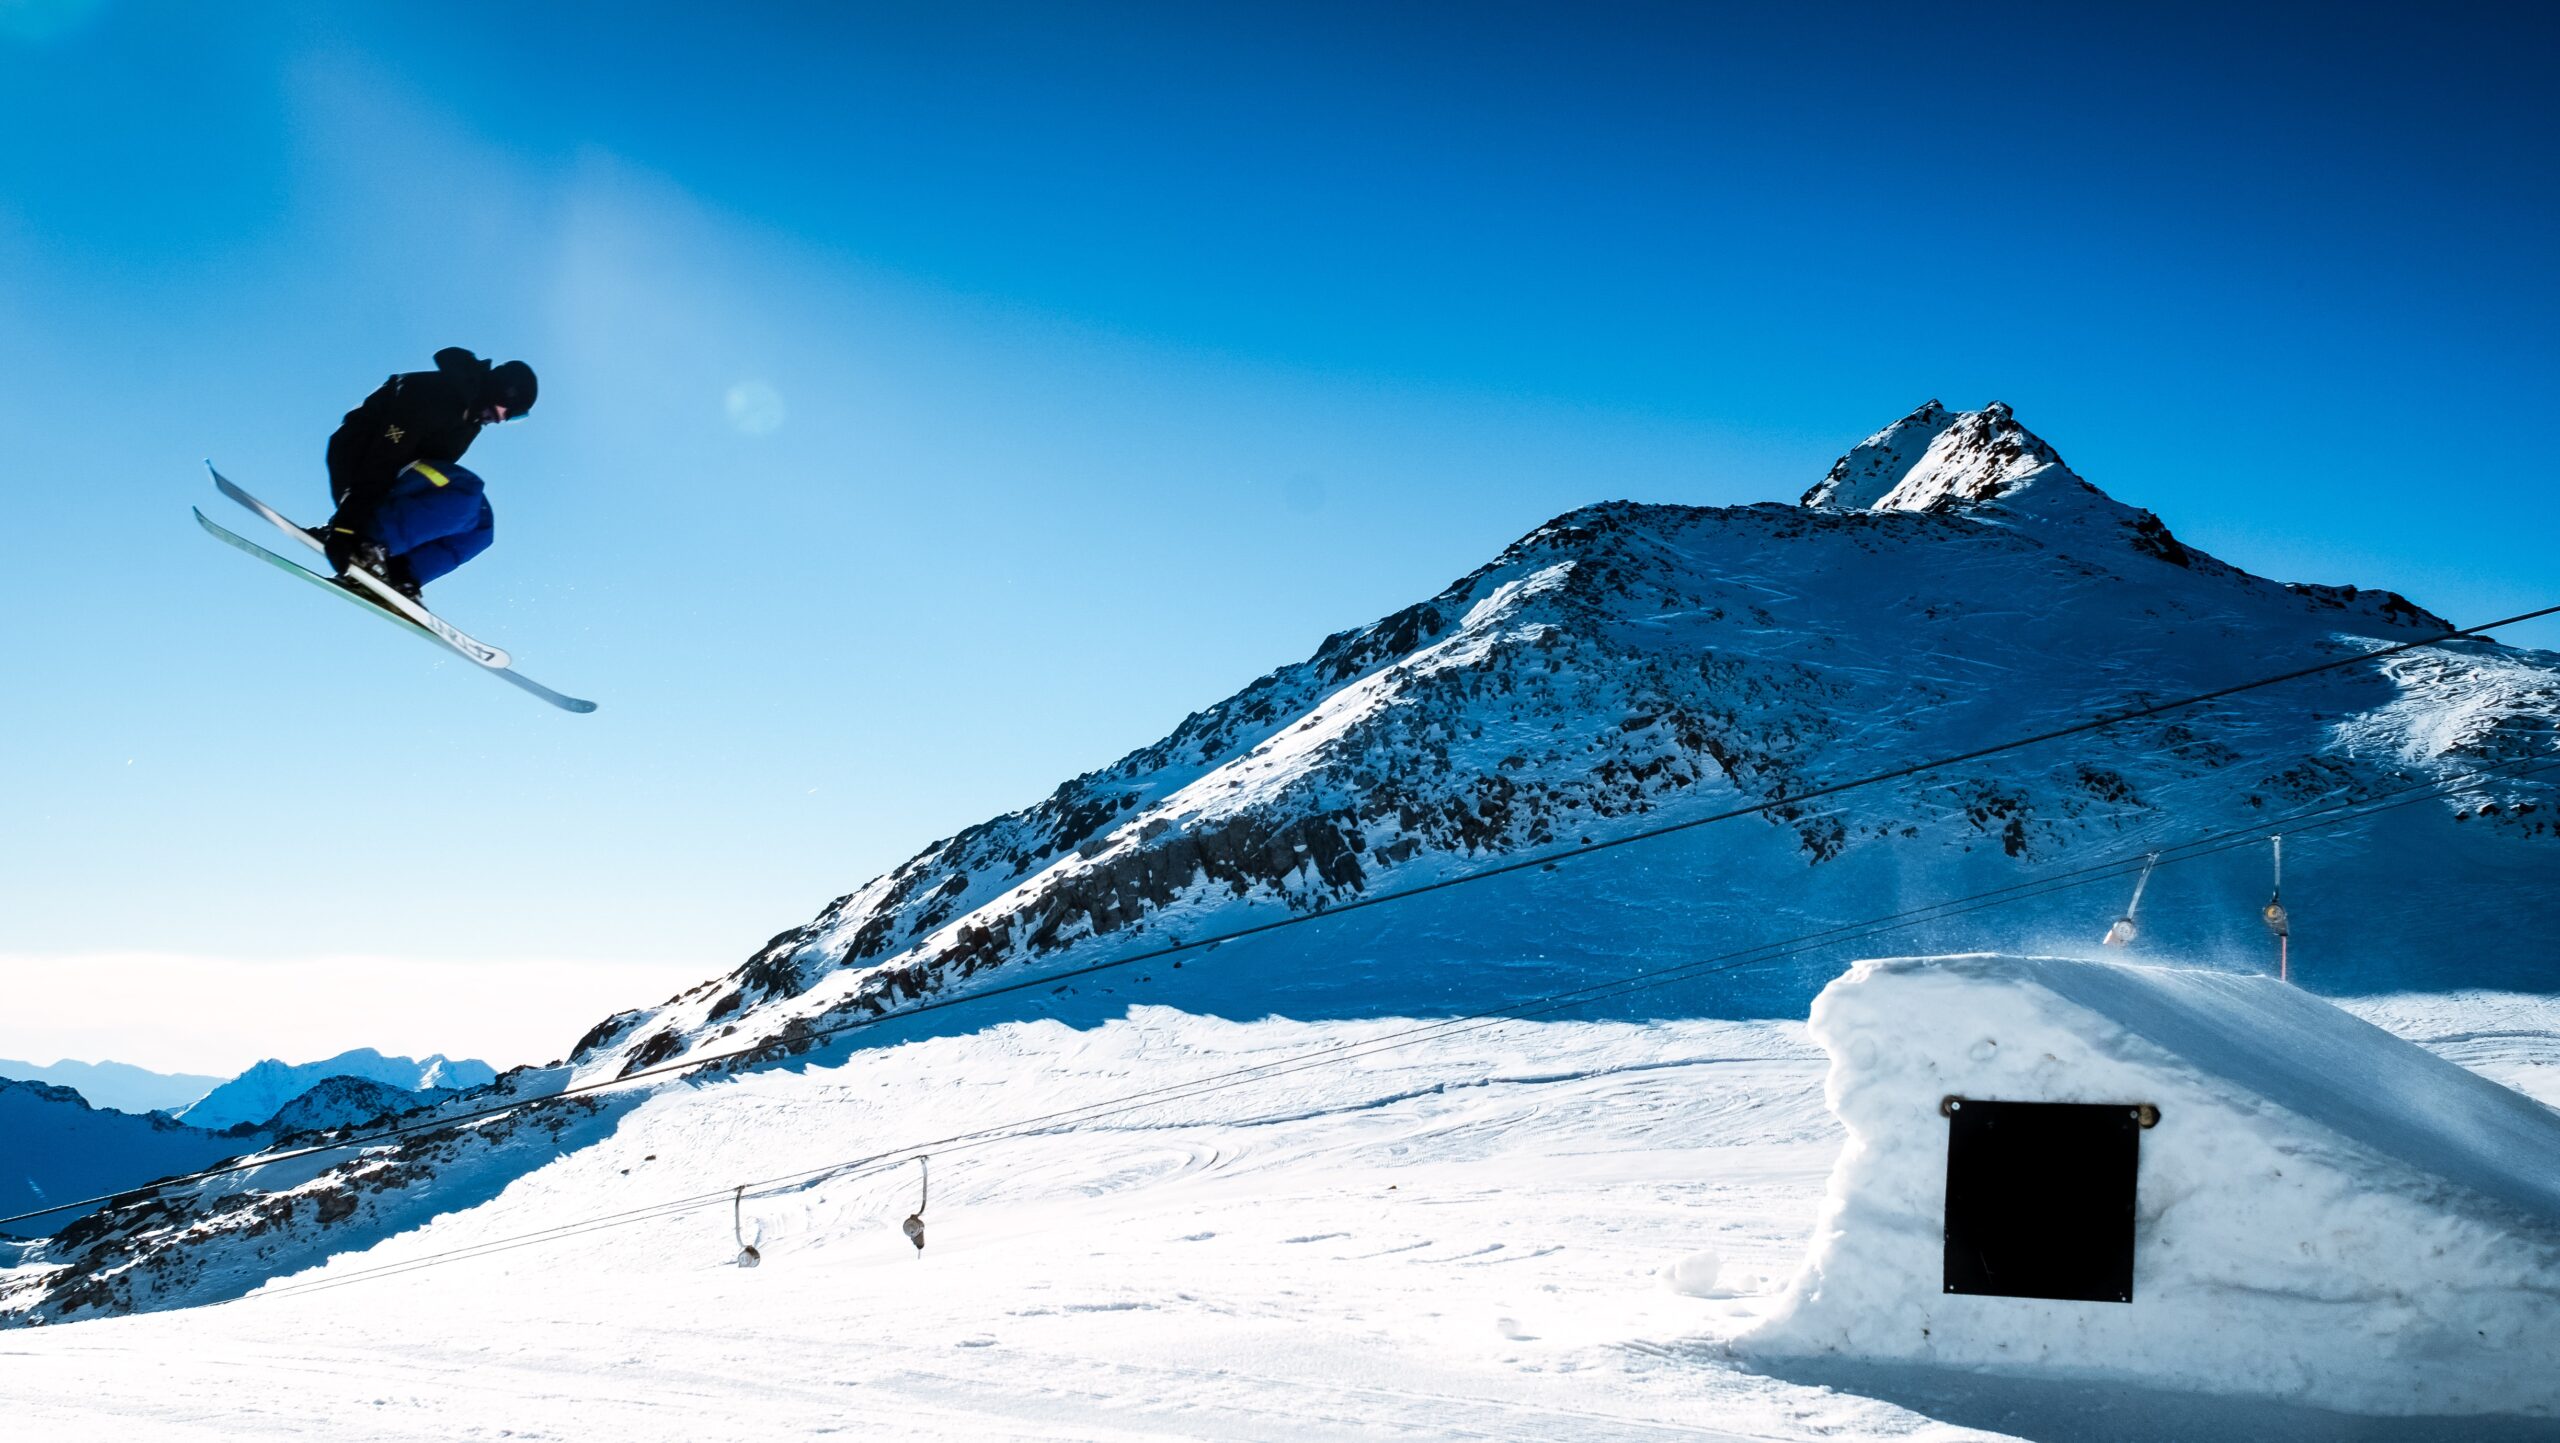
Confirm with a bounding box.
[1738,954,2560,1415]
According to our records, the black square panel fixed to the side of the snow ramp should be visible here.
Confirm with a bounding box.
[1938,1098,2158,1302]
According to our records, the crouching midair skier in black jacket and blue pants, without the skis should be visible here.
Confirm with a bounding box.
[315,345,535,601]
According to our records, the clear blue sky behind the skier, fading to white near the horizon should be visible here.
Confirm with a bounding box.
[0,0,2560,1069]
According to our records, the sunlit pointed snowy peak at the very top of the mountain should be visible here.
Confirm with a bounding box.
[1805,399,2097,512]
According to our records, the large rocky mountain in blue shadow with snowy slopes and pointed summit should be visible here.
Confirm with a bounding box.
[576,402,2560,1075]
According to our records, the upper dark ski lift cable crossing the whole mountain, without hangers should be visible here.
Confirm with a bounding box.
[0,726,2560,1226]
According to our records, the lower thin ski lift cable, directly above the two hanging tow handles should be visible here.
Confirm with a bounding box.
[230,762,2560,1302]
